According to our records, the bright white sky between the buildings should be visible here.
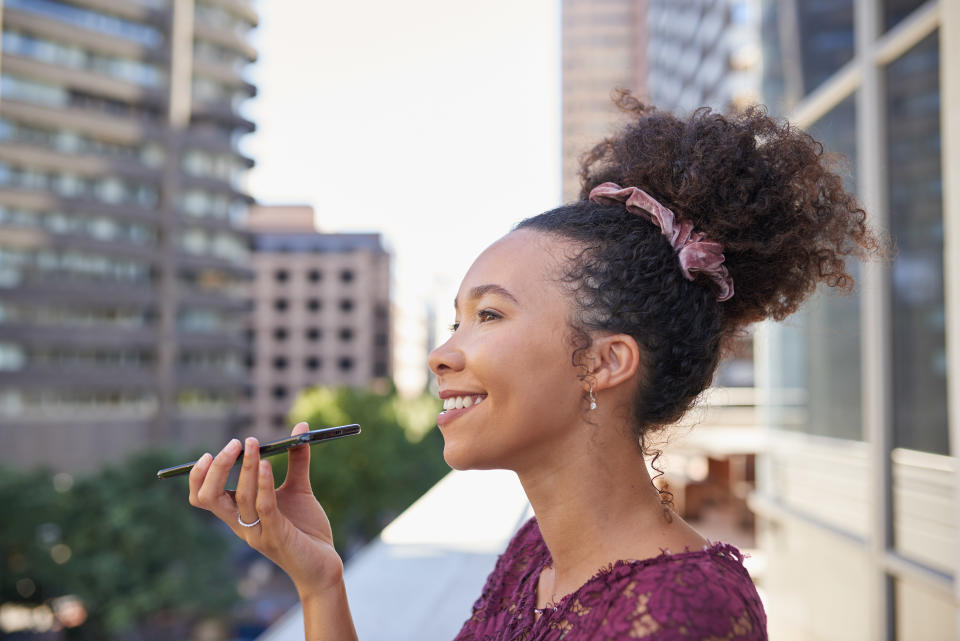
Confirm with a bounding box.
[241,0,560,336]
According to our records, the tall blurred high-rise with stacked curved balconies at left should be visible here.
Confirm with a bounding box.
[0,0,257,470]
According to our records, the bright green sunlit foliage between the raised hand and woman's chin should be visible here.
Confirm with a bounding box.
[284,387,450,554]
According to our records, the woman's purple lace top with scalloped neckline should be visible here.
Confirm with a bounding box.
[455,519,767,641]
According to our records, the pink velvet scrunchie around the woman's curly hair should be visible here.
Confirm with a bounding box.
[590,183,733,303]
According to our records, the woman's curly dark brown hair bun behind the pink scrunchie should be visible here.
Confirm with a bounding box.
[580,91,886,327]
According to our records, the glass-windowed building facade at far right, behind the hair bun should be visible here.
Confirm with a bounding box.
[751,0,960,641]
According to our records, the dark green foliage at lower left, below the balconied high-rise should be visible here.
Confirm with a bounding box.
[0,453,237,639]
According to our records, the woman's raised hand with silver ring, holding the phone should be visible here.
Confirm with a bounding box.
[190,423,343,596]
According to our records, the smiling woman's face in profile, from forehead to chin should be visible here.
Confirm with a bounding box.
[430,230,584,470]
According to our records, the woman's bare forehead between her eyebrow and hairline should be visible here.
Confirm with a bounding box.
[457,229,564,303]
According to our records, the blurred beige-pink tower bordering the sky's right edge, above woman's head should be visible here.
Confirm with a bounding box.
[561,0,648,202]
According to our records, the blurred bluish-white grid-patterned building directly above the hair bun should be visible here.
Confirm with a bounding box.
[646,0,762,114]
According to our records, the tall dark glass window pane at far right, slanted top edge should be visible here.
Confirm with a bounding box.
[886,32,949,454]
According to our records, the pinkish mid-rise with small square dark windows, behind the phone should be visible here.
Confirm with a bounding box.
[247,206,391,438]
